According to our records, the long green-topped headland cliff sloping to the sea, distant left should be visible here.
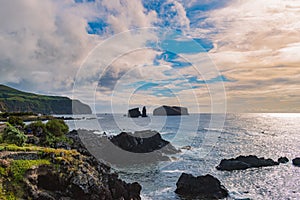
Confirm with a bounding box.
[0,85,92,114]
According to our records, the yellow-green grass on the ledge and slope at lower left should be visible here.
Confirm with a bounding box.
[0,144,82,200]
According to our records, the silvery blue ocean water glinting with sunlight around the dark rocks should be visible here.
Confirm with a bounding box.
[63,113,300,200]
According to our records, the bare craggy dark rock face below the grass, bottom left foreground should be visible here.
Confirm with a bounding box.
[24,155,141,200]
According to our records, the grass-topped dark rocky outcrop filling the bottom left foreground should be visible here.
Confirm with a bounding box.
[0,139,142,200]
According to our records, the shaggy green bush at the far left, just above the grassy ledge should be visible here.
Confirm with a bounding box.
[2,123,27,146]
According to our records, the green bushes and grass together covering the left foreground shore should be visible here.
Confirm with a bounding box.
[0,113,77,199]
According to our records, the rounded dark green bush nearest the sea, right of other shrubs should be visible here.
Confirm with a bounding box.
[46,119,69,137]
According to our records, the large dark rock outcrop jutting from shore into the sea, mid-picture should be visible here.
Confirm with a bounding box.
[72,130,180,166]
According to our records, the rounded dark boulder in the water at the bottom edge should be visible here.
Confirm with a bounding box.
[175,173,228,199]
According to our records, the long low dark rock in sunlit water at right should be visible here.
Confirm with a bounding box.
[216,155,279,171]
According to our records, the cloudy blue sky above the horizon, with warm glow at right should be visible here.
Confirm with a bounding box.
[0,0,300,113]
